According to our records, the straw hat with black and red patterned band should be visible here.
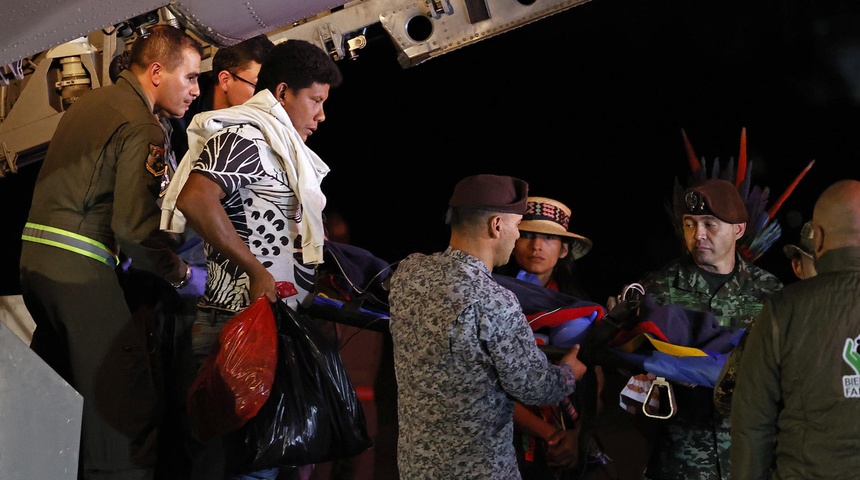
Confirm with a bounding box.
[519,197,592,259]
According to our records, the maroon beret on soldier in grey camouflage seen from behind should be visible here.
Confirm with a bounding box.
[448,174,529,214]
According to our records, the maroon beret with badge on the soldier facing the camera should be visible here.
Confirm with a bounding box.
[684,178,749,223]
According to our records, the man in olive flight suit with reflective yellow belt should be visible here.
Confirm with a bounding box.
[21,25,202,480]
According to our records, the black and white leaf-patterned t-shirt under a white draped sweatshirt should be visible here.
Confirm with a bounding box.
[193,125,314,311]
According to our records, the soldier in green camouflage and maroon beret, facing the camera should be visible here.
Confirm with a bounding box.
[640,179,782,480]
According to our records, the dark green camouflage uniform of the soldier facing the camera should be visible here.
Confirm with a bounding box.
[640,256,782,480]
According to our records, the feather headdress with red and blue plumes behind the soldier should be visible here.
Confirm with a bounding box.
[669,128,815,262]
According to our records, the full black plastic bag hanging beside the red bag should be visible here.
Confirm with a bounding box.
[225,301,373,472]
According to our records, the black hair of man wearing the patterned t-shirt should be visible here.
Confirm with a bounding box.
[257,39,343,94]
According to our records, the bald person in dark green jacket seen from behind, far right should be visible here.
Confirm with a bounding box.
[731,180,860,480]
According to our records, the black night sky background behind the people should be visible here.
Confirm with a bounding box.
[0,0,860,302]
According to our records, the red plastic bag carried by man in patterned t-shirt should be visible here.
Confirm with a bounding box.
[186,288,278,439]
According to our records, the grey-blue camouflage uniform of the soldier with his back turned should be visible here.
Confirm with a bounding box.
[389,247,575,480]
